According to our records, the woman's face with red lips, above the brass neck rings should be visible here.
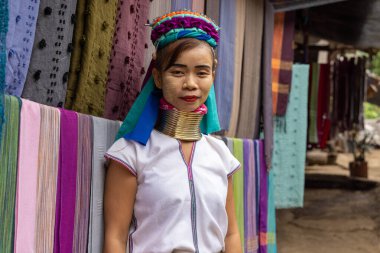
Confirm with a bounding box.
[153,45,215,112]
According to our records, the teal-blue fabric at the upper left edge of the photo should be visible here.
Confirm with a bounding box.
[0,0,8,149]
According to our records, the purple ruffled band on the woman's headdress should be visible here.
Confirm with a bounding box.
[150,17,219,44]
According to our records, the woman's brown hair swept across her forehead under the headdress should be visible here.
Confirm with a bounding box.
[155,38,216,72]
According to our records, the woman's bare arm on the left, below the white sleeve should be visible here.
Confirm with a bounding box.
[103,160,137,253]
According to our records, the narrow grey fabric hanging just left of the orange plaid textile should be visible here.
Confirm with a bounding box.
[262,0,274,169]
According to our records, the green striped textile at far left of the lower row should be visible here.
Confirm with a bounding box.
[0,96,21,253]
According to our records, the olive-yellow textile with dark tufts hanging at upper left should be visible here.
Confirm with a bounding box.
[69,0,118,116]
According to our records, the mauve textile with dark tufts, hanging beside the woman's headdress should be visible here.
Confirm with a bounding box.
[104,0,149,120]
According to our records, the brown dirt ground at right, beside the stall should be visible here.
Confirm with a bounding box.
[277,150,380,253]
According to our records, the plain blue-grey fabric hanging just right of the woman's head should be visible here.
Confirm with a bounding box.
[215,1,236,130]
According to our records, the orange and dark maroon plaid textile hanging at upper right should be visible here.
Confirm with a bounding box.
[272,12,295,116]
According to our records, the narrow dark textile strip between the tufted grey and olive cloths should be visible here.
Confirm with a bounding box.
[65,0,87,108]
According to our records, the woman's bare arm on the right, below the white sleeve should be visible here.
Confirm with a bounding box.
[224,176,243,253]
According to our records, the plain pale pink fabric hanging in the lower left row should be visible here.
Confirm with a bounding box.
[14,99,41,253]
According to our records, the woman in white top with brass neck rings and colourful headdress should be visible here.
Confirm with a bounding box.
[104,11,242,253]
